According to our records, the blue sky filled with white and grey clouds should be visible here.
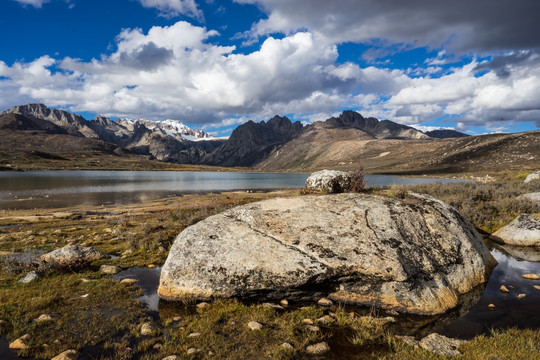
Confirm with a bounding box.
[0,0,540,135]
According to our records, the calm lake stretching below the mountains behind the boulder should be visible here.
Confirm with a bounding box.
[0,171,460,209]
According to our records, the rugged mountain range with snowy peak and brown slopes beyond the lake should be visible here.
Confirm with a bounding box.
[0,104,540,173]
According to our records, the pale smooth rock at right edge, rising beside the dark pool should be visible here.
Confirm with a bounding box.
[492,214,540,246]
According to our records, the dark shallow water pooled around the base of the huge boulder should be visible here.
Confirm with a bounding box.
[115,243,540,339]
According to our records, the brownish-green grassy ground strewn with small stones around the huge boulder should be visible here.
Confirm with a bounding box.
[0,174,540,359]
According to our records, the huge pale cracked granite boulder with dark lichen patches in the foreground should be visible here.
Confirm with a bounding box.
[158,193,496,314]
